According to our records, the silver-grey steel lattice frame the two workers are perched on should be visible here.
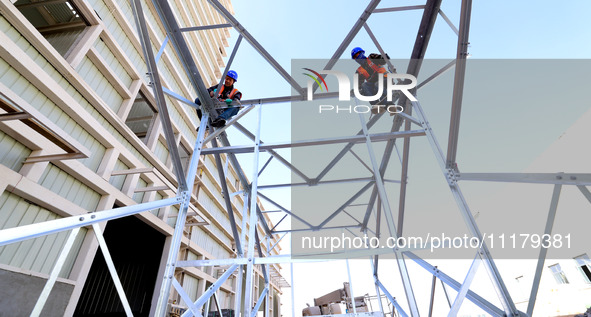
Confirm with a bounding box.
[0,0,591,317]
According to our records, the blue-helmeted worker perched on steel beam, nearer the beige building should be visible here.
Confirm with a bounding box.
[195,70,242,128]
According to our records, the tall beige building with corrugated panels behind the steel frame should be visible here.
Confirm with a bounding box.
[0,0,281,316]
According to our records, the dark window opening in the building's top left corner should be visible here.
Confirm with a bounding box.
[14,0,90,57]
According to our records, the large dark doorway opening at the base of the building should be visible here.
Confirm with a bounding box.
[74,217,165,317]
